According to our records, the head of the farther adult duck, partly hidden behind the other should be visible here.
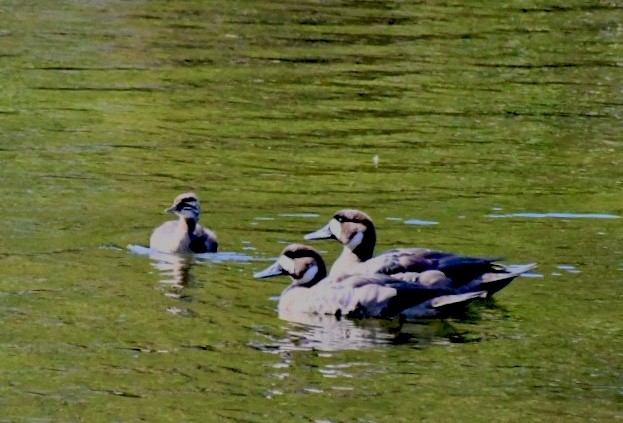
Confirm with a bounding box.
[305,209,376,261]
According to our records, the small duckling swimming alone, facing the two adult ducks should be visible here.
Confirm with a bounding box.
[149,192,218,253]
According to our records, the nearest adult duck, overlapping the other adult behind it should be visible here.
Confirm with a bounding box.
[253,244,487,321]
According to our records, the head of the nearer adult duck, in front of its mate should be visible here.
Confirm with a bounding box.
[253,244,327,287]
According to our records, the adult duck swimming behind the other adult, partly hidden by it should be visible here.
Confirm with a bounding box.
[304,209,536,296]
